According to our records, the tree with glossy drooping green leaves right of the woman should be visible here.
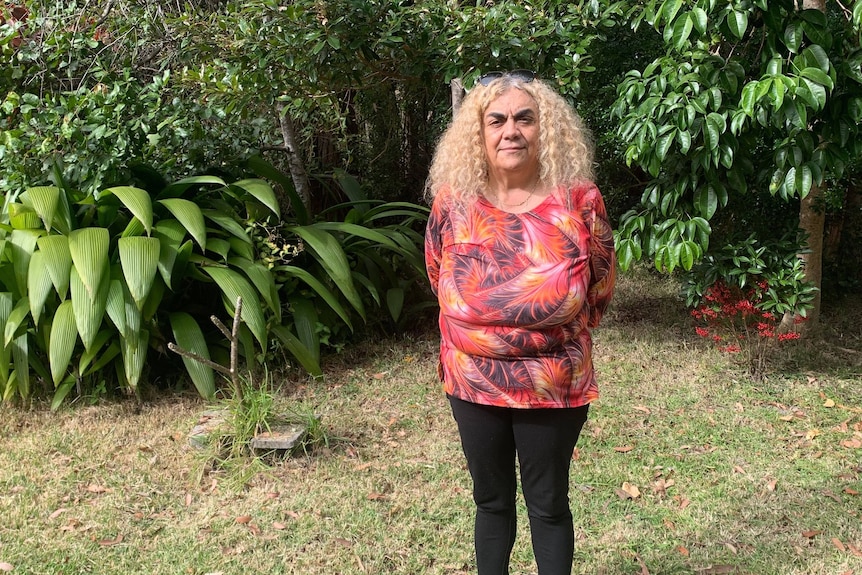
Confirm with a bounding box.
[615,0,862,326]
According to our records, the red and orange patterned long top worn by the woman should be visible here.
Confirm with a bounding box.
[425,183,616,408]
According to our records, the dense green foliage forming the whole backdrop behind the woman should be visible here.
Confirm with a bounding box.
[0,0,862,401]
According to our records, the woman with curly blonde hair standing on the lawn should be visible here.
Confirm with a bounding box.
[425,70,616,575]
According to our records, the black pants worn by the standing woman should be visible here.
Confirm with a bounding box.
[449,397,589,575]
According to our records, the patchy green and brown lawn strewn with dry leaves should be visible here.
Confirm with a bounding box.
[0,276,862,575]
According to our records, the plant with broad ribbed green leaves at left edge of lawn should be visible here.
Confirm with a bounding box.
[0,176,281,407]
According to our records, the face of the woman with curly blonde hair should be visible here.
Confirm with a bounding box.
[482,88,539,178]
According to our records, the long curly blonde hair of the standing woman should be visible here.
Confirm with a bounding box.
[425,75,593,207]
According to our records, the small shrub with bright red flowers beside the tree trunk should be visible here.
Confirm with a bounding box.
[691,280,805,379]
